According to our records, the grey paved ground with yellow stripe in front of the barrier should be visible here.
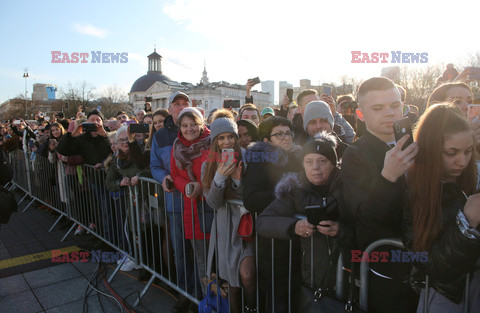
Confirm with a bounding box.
[0,189,177,313]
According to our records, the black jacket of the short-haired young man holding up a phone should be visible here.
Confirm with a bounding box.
[341,132,411,281]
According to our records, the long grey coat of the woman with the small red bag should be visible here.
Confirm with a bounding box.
[202,157,254,287]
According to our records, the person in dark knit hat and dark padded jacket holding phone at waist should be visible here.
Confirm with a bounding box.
[256,132,351,312]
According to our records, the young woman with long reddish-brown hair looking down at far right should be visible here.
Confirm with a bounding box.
[403,103,480,313]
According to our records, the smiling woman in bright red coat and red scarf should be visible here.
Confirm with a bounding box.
[170,107,210,294]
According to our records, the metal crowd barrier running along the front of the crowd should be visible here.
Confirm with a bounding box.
[9,151,476,312]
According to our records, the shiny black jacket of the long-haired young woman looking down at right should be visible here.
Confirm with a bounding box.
[402,183,480,304]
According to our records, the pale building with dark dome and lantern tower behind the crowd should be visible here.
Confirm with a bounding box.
[128,50,273,113]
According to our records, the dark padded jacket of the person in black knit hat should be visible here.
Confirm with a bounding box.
[256,168,353,290]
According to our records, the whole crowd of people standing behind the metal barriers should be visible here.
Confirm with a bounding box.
[0,71,480,312]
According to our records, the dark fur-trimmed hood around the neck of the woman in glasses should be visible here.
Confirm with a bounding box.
[245,141,301,166]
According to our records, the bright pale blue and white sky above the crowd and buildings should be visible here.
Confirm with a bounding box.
[0,0,480,102]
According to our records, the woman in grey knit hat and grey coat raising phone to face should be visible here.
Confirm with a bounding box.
[202,110,256,312]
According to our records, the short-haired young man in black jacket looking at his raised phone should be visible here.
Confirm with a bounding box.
[342,77,418,313]
